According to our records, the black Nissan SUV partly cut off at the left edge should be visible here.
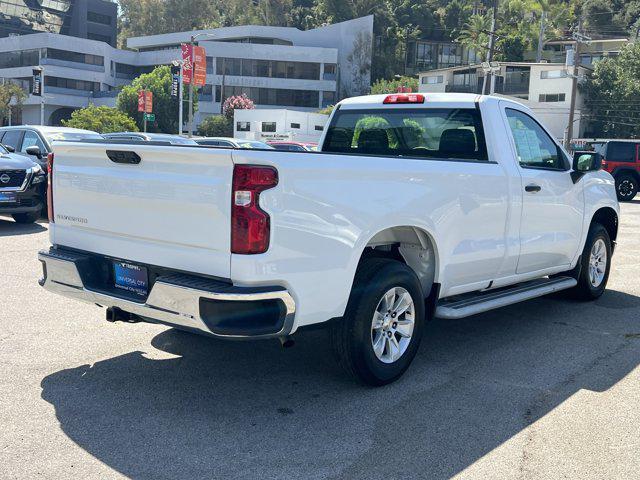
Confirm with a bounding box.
[0,145,47,223]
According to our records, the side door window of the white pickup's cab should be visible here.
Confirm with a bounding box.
[506,108,567,171]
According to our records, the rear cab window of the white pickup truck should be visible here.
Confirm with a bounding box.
[322,108,488,161]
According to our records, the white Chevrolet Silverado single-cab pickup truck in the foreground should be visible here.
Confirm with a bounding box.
[39,94,619,385]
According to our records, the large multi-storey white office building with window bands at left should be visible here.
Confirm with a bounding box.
[0,16,373,125]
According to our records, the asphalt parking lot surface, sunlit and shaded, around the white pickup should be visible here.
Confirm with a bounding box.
[0,200,640,479]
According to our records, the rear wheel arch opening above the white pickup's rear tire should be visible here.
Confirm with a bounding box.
[358,225,440,298]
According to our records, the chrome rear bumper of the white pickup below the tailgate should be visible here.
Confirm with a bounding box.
[38,248,295,339]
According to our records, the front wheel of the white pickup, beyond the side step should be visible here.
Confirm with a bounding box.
[573,223,611,300]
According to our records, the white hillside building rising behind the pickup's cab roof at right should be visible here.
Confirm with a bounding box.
[418,62,591,140]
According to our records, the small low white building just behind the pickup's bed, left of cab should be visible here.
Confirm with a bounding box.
[233,109,329,143]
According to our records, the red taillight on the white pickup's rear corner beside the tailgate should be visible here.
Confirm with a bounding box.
[231,165,278,255]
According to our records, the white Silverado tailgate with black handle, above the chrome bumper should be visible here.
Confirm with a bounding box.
[51,142,233,278]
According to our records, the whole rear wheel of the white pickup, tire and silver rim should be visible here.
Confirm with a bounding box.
[331,258,425,386]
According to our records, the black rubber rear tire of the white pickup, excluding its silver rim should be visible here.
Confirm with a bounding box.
[331,258,425,386]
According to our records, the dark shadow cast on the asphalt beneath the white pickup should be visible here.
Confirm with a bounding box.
[41,291,640,479]
